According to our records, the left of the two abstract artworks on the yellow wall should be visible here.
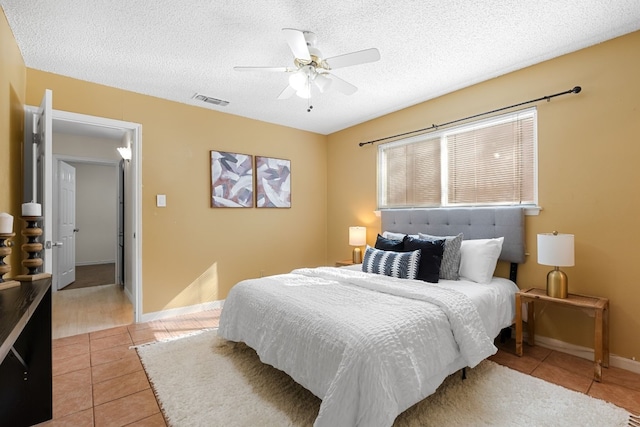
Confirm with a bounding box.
[211,150,253,208]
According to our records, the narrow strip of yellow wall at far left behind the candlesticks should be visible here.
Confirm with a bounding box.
[0,13,26,279]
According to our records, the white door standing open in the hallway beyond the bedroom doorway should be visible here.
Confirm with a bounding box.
[54,161,77,289]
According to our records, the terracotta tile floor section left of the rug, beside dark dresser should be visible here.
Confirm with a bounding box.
[40,310,220,427]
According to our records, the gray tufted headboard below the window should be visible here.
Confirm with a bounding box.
[381,207,525,264]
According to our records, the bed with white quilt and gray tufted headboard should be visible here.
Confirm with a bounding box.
[218,208,525,427]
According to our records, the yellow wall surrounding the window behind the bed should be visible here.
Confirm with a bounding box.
[328,32,640,358]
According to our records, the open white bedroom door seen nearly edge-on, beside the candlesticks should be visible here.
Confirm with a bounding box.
[36,89,53,274]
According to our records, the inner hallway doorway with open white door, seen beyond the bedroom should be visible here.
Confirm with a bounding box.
[53,159,124,290]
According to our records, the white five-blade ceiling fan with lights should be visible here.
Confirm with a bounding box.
[233,28,380,105]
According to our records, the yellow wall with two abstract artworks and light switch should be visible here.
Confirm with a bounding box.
[26,69,327,313]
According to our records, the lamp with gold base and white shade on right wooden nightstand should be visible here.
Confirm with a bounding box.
[538,231,574,298]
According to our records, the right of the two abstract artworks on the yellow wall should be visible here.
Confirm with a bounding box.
[256,156,291,208]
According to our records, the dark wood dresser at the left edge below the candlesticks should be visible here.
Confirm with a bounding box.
[0,278,53,427]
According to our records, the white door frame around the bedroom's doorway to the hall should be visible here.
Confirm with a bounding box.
[24,105,142,323]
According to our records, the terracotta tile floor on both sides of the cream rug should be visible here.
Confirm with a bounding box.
[41,310,640,427]
